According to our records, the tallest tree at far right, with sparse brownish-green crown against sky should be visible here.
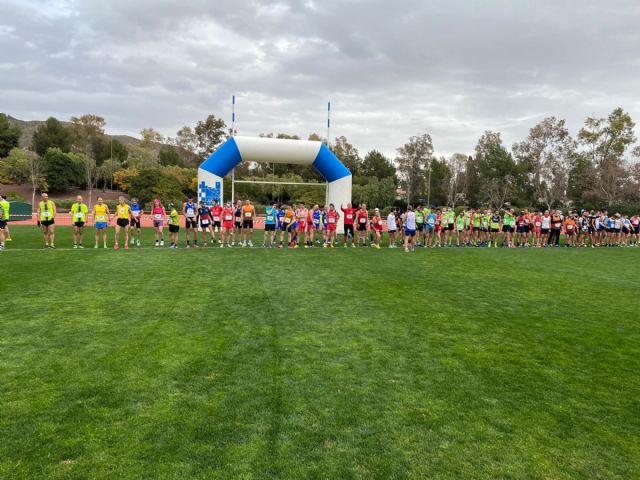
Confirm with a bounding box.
[578,108,636,205]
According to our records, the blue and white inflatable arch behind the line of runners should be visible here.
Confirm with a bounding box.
[198,137,352,216]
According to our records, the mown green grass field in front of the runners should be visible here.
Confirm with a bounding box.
[0,226,640,479]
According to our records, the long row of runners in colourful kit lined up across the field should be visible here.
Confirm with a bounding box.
[0,193,640,251]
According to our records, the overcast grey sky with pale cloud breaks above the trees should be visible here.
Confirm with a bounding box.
[0,0,640,155]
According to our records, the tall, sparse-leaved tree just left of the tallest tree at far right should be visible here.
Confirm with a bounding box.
[513,117,575,209]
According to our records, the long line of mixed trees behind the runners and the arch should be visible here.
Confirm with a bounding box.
[0,108,640,213]
